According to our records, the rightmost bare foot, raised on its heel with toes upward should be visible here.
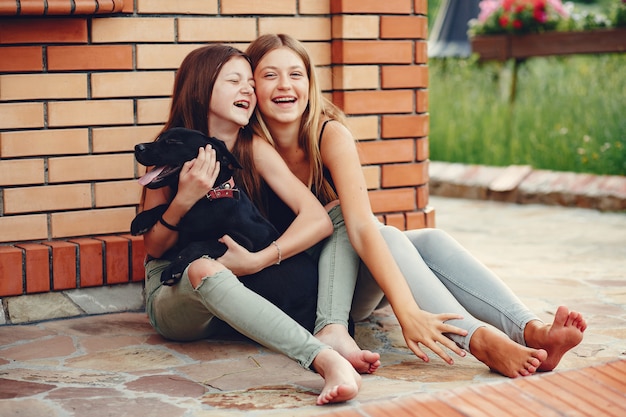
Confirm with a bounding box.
[524,306,587,371]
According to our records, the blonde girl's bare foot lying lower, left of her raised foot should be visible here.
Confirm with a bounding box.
[470,327,548,378]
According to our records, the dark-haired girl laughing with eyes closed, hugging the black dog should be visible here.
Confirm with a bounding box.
[136,45,361,404]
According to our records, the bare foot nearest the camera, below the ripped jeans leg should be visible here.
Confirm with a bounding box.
[313,349,361,405]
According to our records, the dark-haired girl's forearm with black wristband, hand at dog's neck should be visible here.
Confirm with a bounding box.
[143,145,220,258]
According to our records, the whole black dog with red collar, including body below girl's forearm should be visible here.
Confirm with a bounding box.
[131,128,318,330]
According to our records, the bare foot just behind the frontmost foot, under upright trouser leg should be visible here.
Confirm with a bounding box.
[315,324,380,374]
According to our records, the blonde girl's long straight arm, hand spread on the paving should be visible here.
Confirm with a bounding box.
[321,122,465,363]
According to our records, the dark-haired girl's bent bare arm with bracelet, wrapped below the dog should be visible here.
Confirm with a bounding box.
[218,137,333,275]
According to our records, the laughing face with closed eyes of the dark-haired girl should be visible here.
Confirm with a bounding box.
[209,56,256,132]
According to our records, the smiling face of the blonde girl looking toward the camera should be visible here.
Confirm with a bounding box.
[254,47,309,126]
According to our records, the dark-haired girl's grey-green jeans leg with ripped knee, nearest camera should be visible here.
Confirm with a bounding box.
[145,260,329,368]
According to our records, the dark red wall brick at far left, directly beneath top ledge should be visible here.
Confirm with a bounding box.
[0,17,87,44]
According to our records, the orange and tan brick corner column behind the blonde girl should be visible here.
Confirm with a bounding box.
[331,0,428,230]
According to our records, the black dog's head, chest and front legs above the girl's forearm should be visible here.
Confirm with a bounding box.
[131,128,279,285]
